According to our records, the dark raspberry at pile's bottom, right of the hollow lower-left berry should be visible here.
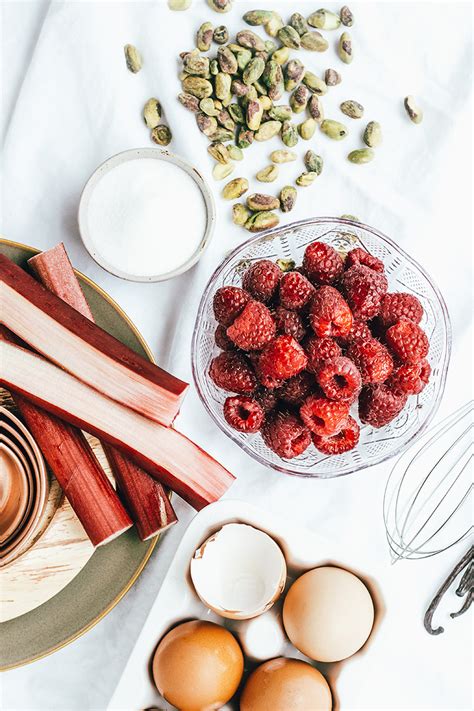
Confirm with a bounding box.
[262,410,311,459]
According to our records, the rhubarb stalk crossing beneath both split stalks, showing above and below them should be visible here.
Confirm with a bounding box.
[28,243,178,541]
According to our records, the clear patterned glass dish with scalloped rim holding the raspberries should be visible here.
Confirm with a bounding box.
[192,217,451,479]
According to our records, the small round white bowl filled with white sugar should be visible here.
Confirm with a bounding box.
[78,148,216,282]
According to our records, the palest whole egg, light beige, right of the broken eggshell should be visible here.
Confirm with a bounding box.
[283,566,374,662]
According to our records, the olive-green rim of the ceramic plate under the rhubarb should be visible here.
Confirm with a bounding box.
[0,240,157,671]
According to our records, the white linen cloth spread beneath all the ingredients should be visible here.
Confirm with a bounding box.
[0,0,472,710]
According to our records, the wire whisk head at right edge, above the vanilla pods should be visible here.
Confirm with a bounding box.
[383,401,474,563]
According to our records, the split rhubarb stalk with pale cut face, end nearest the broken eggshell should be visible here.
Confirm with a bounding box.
[0,340,234,509]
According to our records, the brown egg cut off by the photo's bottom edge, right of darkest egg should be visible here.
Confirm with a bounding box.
[240,657,332,711]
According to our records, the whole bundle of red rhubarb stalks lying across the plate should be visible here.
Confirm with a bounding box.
[0,244,233,546]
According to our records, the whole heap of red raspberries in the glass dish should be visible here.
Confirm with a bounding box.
[209,242,431,459]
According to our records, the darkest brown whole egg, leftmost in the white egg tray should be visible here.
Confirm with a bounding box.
[153,620,244,711]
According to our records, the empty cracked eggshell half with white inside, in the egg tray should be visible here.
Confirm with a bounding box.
[190,523,286,620]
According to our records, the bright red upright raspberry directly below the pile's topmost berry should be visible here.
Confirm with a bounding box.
[309,286,352,338]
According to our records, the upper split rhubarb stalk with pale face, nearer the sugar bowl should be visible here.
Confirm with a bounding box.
[0,255,188,425]
